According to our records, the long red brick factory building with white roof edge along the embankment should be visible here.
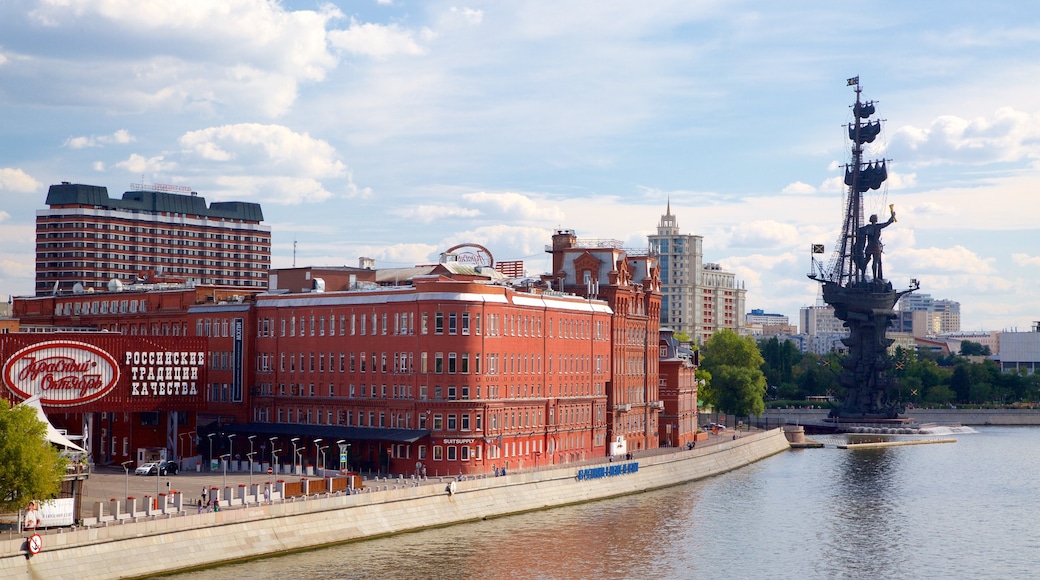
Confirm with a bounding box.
[6,231,696,475]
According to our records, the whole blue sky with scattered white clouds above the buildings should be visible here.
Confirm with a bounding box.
[0,0,1040,331]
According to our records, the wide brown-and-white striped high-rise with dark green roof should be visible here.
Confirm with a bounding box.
[35,182,270,296]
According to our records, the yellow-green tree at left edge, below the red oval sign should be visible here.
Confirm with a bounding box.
[0,399,68,512]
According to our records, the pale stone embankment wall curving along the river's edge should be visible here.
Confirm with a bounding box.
[0,429,789,580]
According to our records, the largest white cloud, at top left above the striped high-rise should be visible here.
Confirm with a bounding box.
[24,0,343,116]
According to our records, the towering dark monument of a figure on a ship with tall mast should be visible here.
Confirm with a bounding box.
[809,77,920,421]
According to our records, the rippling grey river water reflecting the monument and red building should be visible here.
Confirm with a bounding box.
[156,427,1040,580]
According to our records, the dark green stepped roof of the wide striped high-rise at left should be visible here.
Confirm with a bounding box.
[47,183,263,221]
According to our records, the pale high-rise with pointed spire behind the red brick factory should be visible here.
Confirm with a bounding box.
[649,202,747,344]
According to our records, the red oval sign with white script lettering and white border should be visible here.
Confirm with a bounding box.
[3,341,120,406]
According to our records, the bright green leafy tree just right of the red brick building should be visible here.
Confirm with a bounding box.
[701,328,765,416]
